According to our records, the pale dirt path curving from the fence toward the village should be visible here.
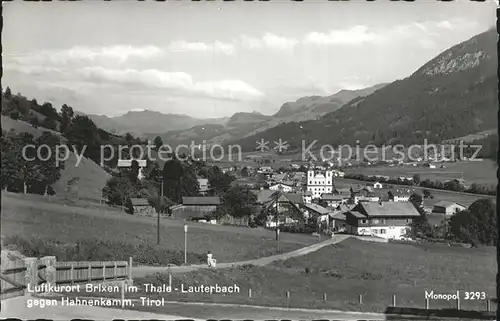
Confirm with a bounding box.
[132,235,351,278]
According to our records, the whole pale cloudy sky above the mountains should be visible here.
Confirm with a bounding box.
[2,0,496,118]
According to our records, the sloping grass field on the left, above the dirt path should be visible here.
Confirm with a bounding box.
[1,193,317,263]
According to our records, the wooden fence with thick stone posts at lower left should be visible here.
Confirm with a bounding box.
[0,256,132,300]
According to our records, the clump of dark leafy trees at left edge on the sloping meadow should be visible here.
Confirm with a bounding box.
[1,131,64,194]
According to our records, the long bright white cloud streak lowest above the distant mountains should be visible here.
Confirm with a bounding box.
[77,66,264,100]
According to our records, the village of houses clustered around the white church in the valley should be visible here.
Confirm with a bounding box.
[125,155,467,240]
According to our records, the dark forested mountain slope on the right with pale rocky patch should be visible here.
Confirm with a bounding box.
[231,30,498,151]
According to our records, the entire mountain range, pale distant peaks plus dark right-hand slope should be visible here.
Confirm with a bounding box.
[83,29,498,151]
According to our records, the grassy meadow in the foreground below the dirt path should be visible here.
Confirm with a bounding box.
[123,238,497,312]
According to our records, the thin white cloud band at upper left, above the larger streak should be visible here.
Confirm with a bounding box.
[9,45,162,65]
